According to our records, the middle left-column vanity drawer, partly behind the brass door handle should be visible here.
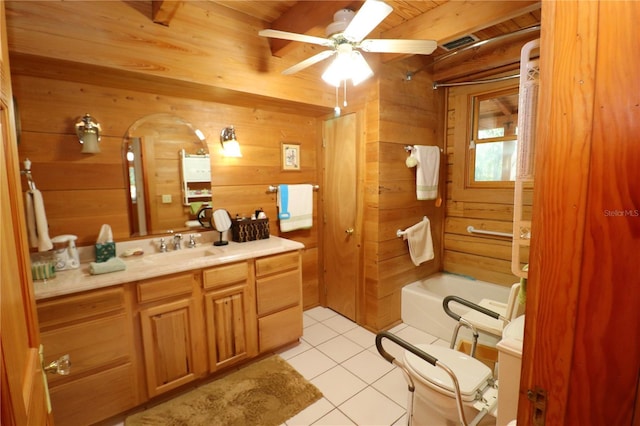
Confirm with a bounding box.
[41,313,131,385]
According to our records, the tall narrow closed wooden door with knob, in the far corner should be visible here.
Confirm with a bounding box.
[323,114,362,321]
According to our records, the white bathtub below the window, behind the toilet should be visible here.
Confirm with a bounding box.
[401,272,510,346]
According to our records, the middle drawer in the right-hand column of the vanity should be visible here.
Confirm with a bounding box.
[256,269,301,316]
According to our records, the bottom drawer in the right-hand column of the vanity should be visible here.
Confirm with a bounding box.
[258,306,302,353]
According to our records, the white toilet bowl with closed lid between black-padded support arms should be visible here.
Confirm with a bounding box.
[403,344,498,426]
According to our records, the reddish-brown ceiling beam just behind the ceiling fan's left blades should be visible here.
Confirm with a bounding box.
[262,0,363,57]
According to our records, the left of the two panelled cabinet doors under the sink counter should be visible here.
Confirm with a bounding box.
[140,299,197,397]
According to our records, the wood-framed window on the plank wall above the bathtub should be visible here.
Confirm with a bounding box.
[467,88,518,188]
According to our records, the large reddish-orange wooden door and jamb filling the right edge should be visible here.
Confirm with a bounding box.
[518,1,640,425]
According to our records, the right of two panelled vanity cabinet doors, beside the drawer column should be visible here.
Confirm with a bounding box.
[204,284,257,372]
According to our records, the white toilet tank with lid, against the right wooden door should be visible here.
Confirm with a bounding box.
[496,315,524,426]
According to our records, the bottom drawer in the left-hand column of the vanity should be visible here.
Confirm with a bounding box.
[49,364,139,426]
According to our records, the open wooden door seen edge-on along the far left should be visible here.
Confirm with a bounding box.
[0,2,53,426]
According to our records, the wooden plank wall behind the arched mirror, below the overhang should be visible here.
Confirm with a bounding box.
[13,74,320,305]
